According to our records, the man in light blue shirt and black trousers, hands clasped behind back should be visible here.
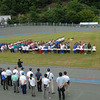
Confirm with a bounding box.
[56,72,65,100]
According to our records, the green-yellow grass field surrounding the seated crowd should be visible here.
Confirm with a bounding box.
[0,31,100,68]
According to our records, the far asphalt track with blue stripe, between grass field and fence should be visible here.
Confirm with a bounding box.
[0,26,100,38]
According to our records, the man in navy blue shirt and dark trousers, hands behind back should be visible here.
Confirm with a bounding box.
[35,68,42,92]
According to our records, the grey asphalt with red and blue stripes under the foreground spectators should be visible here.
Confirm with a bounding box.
[0,63,100,100]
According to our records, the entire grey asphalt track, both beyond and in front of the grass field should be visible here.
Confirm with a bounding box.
[0,26,100,100]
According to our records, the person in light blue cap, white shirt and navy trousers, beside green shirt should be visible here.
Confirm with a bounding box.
[20,72,26,94]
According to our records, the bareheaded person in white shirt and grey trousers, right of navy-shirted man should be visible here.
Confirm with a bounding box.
[42,74,51,100]
